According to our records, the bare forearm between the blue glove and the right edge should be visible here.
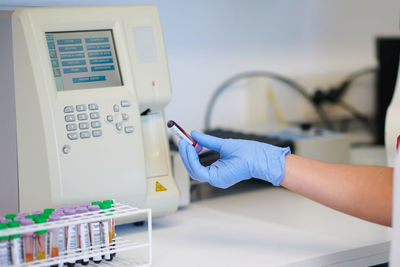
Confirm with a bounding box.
[281,155,393,226]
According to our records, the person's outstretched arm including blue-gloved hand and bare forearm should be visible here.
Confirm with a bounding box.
[179,131,393,226]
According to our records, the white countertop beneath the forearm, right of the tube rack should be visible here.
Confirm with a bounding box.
[114,187,391,266]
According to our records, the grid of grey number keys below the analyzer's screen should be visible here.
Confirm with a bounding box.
[63,103,103,140]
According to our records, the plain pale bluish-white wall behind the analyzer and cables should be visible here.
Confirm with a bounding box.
[0,0,400,132]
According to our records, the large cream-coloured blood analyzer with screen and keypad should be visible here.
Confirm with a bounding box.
[12,6,179,220]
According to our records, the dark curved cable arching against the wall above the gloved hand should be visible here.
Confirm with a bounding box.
[204,71,332,130]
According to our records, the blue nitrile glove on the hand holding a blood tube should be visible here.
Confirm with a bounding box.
[179,131,290,188]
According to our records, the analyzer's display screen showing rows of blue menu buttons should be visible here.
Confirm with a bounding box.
[46,30,123,91]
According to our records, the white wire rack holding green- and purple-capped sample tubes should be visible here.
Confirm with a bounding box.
[1,203,152,267]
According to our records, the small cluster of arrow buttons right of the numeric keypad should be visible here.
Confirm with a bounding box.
[105,99,135,134]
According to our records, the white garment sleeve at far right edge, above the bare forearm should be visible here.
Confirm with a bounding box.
[385,56,400,167]
